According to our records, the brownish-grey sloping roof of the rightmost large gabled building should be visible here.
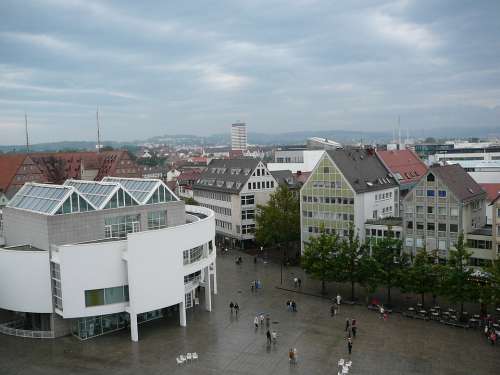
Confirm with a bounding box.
[428,164,486,201]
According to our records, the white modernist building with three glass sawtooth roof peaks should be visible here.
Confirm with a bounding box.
[0,177,217,341]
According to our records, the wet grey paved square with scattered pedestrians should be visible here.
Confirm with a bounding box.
[0,250,500,375]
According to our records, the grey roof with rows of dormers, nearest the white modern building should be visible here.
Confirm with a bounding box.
[193,158,260,194]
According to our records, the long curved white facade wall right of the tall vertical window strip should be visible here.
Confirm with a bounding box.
[55,206,216,318]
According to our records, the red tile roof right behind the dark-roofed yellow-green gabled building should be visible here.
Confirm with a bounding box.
[377,150,427,184]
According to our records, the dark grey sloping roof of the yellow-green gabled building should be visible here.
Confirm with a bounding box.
[326,147,398,193]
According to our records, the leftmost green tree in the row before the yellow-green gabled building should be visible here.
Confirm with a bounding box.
[301,227,340,294]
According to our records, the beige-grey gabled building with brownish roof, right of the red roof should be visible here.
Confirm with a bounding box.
[403,164,486,259]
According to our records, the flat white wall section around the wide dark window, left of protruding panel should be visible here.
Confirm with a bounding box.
[57,240,128,318]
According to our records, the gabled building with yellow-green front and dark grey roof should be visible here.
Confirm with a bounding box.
[300,148,399,250]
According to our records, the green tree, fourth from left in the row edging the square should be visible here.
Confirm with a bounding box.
[402,249,441,306]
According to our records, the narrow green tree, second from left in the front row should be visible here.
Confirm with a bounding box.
[338,225,366,301]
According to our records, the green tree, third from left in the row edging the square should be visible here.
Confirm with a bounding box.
[372,230,408,306]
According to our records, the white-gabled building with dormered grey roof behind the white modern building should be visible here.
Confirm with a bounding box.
[193,158,278,247]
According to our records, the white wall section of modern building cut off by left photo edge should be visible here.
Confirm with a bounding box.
[0,249,52,313]
